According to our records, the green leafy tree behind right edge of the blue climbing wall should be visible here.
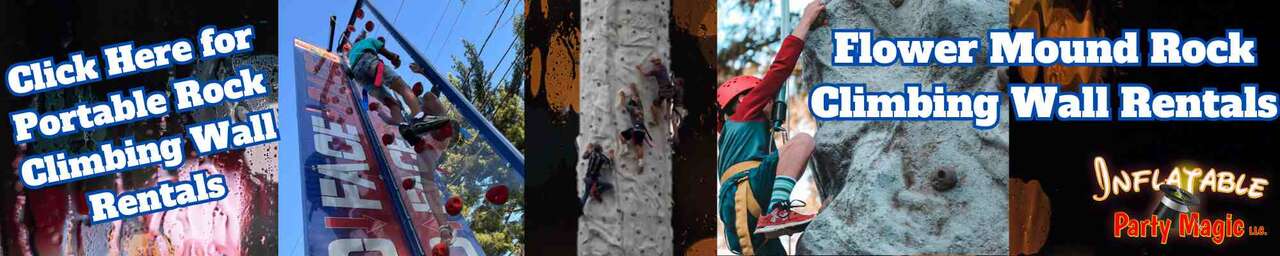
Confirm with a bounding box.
[440,12,525,255]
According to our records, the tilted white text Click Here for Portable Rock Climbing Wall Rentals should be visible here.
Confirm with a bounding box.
[5,26,278,224]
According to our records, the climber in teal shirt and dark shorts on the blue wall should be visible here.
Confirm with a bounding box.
[347,37,449,140]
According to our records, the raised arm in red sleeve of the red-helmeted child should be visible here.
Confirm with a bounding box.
[730,0,827,122]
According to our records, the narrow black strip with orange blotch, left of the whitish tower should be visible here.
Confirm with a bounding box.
[525,0,581,255]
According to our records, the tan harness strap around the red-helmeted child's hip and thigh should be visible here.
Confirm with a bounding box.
[721,161,763,255]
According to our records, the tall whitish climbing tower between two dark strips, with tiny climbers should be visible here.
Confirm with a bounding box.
[577,0,672,255]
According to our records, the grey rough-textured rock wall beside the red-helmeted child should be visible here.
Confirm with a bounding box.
[799,0,1009,255]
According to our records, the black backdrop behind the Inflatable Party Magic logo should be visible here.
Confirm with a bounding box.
[1010,1,1280,255]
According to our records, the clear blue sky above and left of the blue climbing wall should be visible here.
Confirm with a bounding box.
[278,0,524,255]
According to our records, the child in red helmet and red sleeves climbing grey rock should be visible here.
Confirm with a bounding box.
[716,1,826,255]
